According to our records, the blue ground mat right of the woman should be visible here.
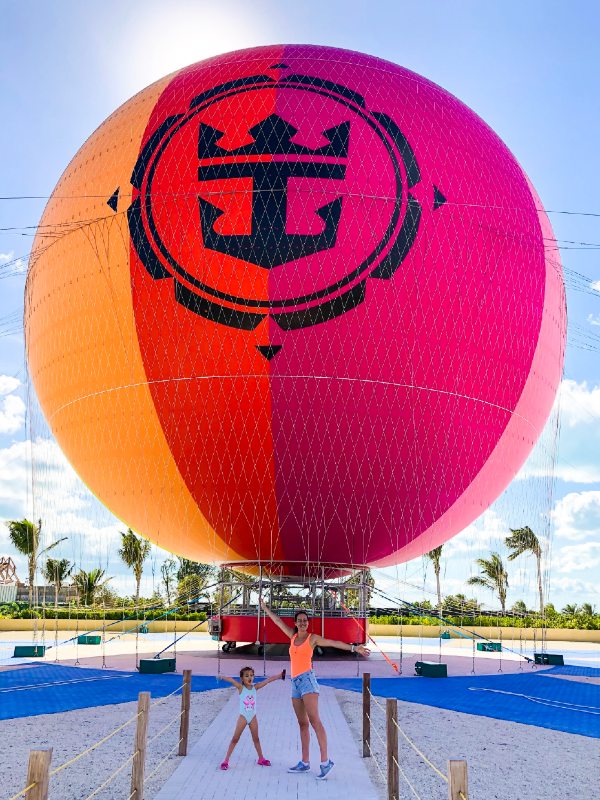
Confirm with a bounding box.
[319,667,600,739]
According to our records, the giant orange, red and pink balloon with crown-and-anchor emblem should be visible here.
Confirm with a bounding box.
[26,45,564,575]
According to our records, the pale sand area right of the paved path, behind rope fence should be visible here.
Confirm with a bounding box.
[337,690,600,800]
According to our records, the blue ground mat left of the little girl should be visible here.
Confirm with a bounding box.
[0,664,223,720]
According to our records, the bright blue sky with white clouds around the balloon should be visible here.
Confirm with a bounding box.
[0,0,600,606]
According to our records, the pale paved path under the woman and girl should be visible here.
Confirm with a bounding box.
[155,681,377,800]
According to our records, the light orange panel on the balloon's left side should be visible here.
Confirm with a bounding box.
[26,73,246,561]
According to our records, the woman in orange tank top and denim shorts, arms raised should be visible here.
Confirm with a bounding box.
[260,598,370,781]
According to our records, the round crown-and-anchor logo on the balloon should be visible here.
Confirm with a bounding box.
[126,65,445,330]
